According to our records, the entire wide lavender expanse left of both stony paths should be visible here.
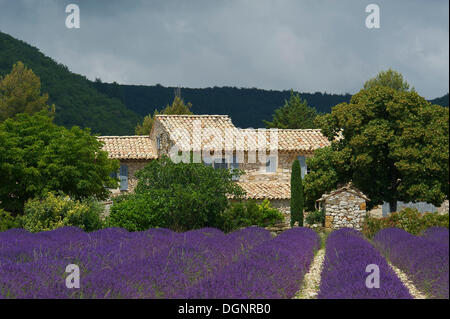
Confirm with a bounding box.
[0,227,319,298]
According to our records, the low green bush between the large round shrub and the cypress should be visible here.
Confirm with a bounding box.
[220,199,284,232]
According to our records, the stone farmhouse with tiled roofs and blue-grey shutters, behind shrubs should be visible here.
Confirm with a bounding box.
[98,115,330,222]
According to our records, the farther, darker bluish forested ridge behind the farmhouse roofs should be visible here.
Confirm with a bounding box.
[95,81,351,128]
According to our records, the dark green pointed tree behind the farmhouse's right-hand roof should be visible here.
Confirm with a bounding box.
[264,90,317,129]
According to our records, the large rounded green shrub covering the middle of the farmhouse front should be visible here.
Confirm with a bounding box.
[109,156,243,231]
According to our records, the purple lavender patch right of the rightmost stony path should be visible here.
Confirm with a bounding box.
[373,227,449,299]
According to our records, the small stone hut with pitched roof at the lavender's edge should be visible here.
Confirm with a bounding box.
[317,183,369,230]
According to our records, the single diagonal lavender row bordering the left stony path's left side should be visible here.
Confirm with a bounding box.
[187,228,320,299]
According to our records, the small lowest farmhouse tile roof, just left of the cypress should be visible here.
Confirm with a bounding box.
[232,182,291,200]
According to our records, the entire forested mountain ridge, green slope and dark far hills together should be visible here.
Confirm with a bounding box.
[0,32,449,135]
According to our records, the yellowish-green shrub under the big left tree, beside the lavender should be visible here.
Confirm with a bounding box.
[21,193,103,232]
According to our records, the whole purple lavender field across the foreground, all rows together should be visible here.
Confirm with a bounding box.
[0,227,449,299]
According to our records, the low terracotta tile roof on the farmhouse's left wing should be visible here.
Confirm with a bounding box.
[97,135,157,160]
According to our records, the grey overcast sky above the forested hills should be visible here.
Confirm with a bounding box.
[0,0,449,98]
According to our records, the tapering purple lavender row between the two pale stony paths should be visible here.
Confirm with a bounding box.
[318,228,412,299]
